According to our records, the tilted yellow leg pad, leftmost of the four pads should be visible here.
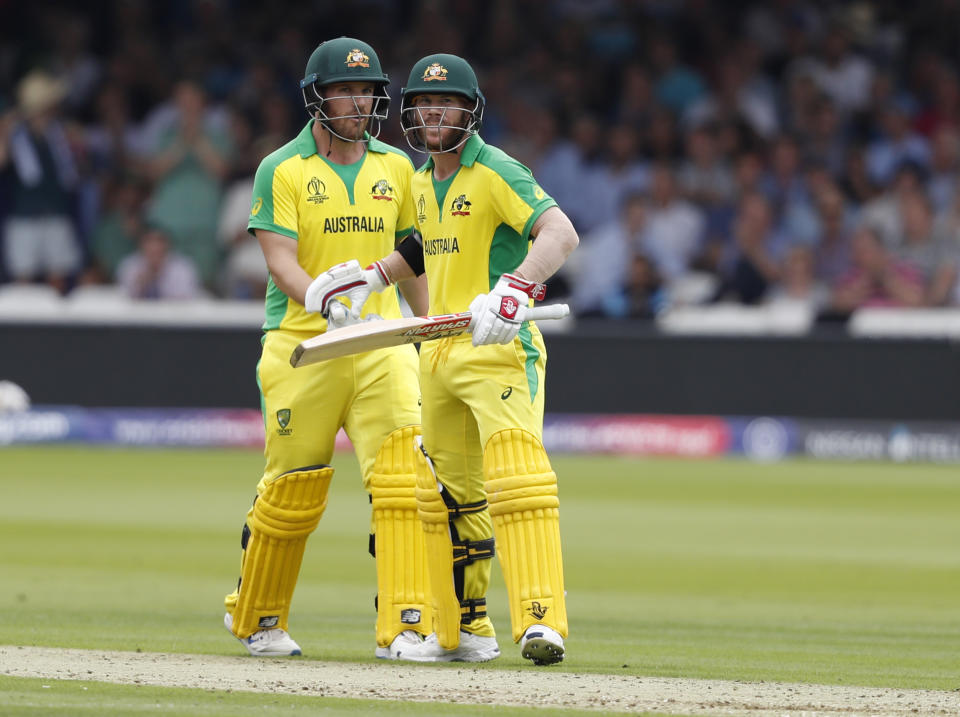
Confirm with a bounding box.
[233,466,333,637]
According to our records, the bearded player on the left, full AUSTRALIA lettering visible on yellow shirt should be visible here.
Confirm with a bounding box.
[224,37,432,659]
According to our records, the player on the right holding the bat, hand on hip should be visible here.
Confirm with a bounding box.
[316,54,579,664]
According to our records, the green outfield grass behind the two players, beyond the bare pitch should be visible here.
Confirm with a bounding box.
[0,447,960,714]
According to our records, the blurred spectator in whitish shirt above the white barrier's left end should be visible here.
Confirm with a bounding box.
[640,163,706,281]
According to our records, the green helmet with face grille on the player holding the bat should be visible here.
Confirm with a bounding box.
[400,53,486,152]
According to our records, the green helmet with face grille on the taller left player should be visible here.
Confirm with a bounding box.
[300,37,390,142]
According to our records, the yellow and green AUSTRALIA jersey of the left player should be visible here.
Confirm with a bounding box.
[247,120,413,334]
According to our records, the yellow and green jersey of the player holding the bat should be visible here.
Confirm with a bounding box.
[410,135,556,314]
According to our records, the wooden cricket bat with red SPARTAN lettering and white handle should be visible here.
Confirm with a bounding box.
[290,304,570,368]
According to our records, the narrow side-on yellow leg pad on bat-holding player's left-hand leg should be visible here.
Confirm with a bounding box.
[416,440,460,650]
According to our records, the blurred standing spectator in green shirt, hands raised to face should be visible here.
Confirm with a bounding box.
[147,80,230,285]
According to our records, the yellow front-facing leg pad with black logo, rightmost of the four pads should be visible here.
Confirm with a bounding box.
[483,429,567,641]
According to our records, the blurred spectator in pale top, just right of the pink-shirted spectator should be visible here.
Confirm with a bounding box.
[893,192,957,306]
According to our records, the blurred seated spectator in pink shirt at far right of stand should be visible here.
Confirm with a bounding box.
[831,226,926,314]
